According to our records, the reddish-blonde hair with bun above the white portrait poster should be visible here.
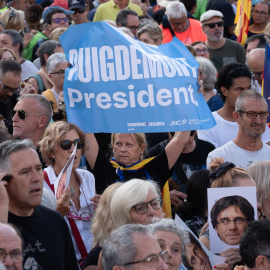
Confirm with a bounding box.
[210,158,252,188]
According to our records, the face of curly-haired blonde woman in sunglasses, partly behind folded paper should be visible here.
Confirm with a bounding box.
[52,129,82,173]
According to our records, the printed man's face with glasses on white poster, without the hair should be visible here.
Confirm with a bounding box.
[215,205,248,246]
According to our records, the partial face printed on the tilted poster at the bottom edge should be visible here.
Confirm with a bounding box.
[186,243,212,270]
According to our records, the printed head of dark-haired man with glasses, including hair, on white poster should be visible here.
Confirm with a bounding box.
[211,196,254,246]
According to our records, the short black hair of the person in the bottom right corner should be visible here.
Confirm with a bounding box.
[240,219,270,268]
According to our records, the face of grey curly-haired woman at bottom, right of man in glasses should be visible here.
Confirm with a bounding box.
[154,231,182,270]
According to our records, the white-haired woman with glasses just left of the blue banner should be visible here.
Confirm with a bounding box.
[42,53,68,110]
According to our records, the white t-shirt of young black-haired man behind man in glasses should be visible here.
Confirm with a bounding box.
[197,112,270,148]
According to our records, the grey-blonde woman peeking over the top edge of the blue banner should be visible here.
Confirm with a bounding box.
[137,22,163,46]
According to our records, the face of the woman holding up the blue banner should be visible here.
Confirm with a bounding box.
[113,133,145,166]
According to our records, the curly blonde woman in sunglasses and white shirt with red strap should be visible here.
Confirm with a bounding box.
[40,121,95,260]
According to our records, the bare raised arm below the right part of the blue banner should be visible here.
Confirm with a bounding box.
[165,130,190,169]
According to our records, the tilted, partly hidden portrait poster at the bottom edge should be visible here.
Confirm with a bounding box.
[175,215,226,270]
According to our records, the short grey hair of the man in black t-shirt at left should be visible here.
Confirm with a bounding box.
[0,139,36,172]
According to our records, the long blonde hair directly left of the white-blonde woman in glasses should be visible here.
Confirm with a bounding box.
[91,182,122,247]
